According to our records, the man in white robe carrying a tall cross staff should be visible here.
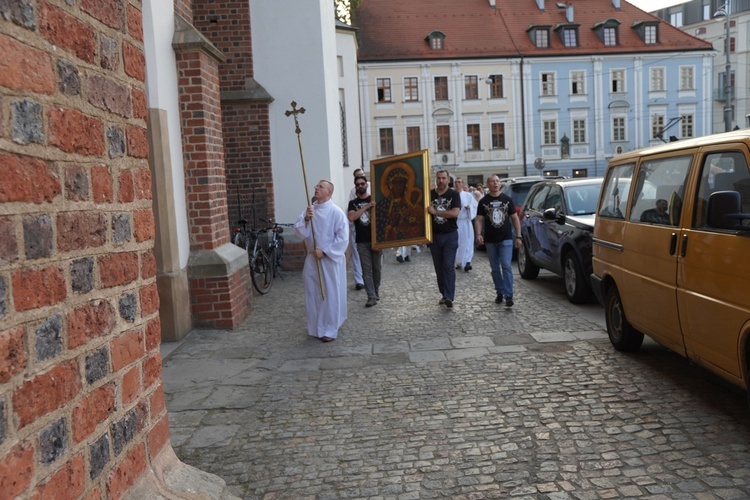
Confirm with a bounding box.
[294,180,349,342]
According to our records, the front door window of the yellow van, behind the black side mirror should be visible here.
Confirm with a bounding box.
[693,151,750,229]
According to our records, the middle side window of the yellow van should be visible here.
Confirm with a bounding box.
[630,155,693,226]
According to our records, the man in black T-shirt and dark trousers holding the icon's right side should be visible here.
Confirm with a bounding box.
[427,170,461,308]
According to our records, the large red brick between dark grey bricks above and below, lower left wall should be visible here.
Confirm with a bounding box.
[13,361,81,428]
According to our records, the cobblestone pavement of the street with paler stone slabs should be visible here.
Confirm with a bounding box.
[162,252,750,499]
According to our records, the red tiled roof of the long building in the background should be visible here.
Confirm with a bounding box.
[353,0,713,62]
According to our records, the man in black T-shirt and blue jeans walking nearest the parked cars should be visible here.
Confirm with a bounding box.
[474,175,521,307]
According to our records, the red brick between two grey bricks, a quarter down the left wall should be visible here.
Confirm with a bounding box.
[47,108,105,156]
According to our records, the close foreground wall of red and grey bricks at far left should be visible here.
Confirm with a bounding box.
[0,0,171,498]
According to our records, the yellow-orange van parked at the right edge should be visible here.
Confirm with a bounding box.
[591,130,750,398]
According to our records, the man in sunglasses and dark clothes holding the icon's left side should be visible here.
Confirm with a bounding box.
[348,175,381,307]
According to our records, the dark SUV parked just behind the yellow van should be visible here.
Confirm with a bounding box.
[518,178,602,304]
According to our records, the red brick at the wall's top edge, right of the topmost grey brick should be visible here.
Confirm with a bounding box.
[39,2,96,64]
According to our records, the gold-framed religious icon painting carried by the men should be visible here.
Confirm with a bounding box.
[370,149,432,250]
